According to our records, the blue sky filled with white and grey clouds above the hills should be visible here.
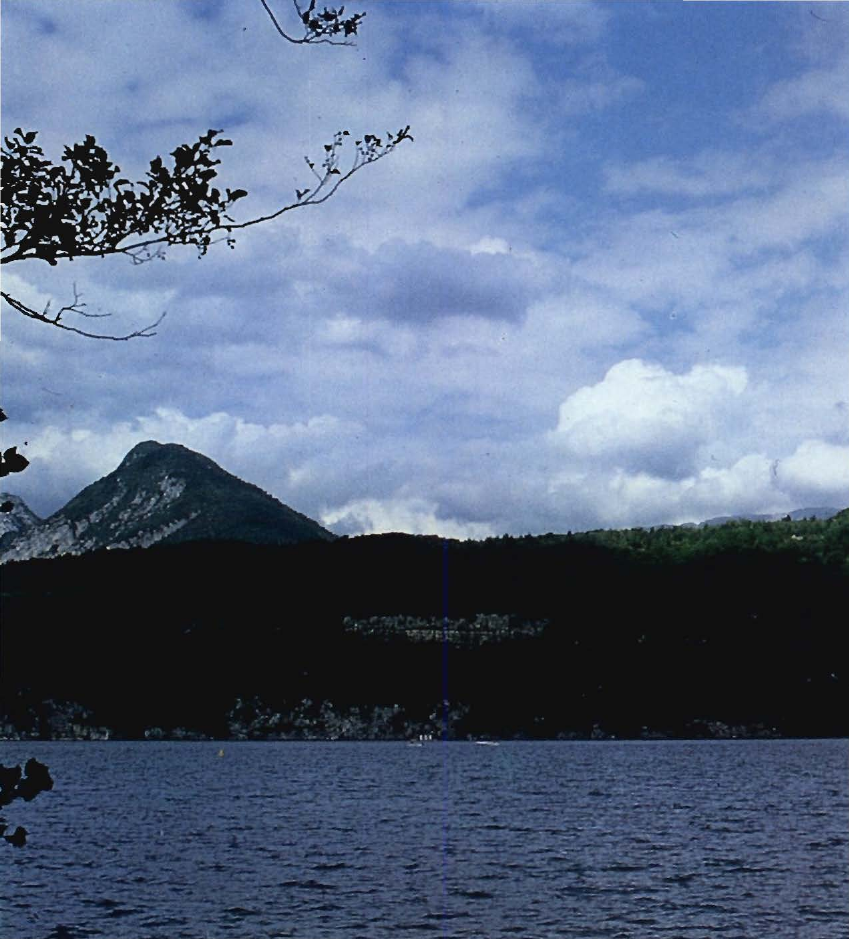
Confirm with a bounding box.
[2,0,849,538]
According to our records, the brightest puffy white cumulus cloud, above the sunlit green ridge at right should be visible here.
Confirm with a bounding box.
[552,359,747,477]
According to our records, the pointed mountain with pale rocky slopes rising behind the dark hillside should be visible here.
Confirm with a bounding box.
[0,440,335,562]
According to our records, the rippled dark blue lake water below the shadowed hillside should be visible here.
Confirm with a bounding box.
[0,740,849,939]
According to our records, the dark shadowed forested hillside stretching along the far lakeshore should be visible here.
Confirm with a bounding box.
[0,512,849,737]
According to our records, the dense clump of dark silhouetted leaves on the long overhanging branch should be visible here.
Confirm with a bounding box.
[2,127,247,265]
